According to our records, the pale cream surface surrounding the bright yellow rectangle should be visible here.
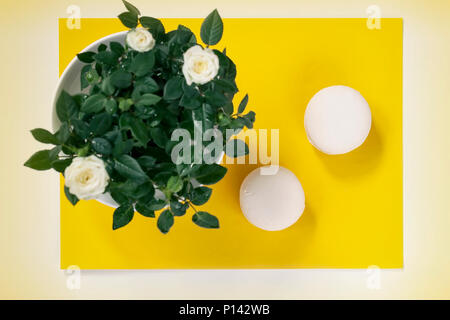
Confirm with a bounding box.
[0,0,450,299]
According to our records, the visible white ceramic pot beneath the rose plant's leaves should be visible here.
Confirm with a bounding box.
[52,31,224,208]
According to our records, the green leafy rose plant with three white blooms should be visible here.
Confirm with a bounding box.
[24,1,255,233]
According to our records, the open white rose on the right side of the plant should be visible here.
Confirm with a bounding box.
[183,46,219,85]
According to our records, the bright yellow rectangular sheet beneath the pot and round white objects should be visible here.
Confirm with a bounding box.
[59,19,403,269]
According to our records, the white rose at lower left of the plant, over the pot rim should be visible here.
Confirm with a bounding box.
[64,155,109,200]
